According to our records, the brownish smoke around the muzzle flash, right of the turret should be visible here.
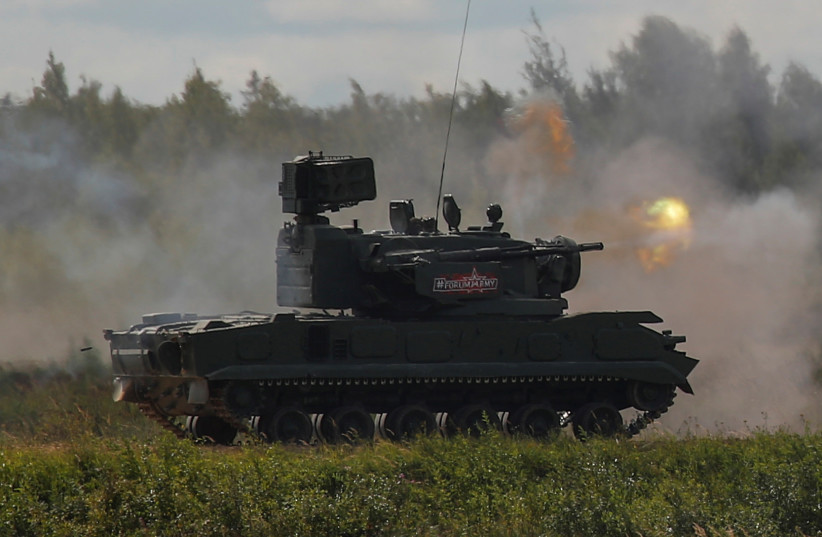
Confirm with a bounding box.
[487,114,822,432]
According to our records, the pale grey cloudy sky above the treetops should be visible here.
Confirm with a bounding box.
[0,0,822,106]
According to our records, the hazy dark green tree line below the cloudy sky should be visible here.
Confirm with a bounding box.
[2,14,822,199]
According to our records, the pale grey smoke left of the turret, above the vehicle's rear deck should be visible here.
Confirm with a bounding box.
[0,118,282,363]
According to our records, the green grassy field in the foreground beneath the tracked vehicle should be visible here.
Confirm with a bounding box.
[0,360,822,536]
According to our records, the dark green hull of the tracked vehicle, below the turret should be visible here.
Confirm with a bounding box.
[108,312,697,418]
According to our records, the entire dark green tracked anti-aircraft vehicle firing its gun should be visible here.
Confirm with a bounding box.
[105,153,697,444]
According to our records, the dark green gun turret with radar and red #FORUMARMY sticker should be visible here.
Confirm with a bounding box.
[277,153,602,318]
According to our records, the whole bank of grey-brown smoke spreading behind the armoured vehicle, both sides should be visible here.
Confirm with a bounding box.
[9,104,822,431]
